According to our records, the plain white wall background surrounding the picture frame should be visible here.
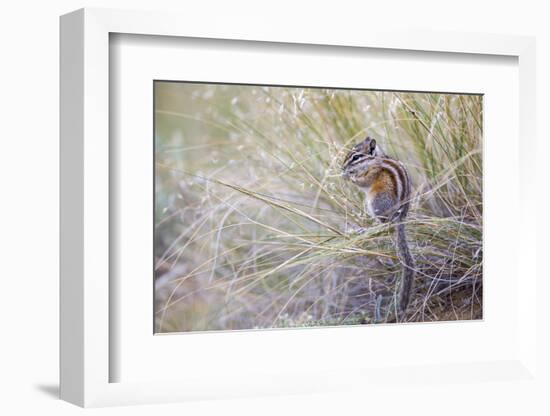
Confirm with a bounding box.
[0,0,550,415]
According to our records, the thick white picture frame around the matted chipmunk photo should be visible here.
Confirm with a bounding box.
[60,9,542,407]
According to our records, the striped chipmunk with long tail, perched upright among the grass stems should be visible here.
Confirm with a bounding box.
[342,137,415,315]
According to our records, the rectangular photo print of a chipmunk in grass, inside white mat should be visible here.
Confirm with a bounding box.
[153,81,483,333]
